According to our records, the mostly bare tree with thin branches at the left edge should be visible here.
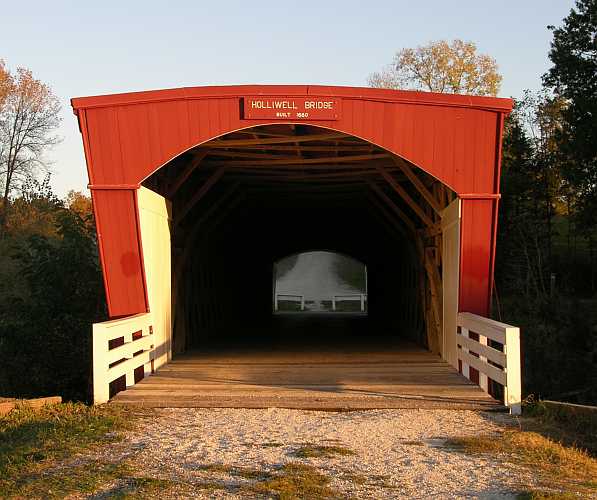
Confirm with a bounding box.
[0,64,60,236]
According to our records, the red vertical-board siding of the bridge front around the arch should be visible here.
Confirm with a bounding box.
[72,85,512,316]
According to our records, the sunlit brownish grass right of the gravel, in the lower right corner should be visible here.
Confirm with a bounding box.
[446,430,597,498]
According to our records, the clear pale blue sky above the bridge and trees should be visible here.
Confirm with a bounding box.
[0,0,573,196]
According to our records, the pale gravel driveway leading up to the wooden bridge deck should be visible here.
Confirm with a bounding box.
[99,408,533,499]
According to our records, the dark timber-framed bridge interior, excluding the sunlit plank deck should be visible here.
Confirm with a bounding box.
[143,124,454,353]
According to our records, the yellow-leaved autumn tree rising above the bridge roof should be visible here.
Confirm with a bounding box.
[369,40,502,96]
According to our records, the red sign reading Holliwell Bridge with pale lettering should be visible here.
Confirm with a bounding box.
[241,96,340,120]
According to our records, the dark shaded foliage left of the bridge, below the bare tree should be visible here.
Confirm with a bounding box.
[0,181,105,400]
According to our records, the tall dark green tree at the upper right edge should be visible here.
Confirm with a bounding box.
[543,0,597,240]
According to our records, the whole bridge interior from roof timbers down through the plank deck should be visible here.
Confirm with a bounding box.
[127,124,495,408]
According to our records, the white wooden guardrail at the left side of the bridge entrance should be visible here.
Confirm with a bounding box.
[93,313,154,404]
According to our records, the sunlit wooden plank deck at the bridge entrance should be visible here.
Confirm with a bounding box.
[112,344,501,411]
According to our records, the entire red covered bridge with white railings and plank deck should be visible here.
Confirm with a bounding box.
[72,85,520,411]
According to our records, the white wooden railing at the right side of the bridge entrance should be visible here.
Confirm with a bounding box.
[456,313,522,415]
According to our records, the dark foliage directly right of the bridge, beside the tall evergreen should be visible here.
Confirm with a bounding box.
[494,93,597,403]
